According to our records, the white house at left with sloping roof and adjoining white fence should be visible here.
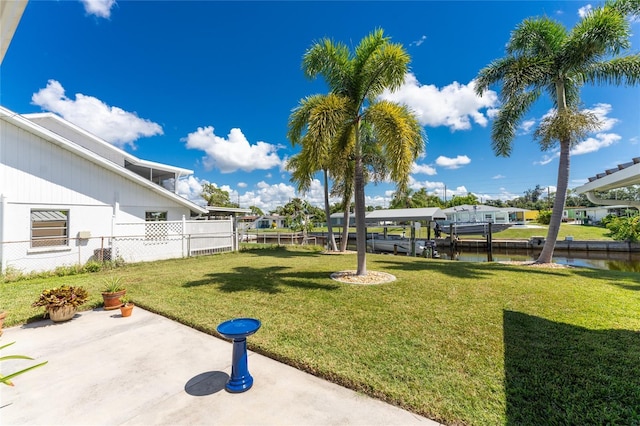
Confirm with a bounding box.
[0,107,234,272]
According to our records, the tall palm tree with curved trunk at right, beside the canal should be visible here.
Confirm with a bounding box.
[476,0,640,263]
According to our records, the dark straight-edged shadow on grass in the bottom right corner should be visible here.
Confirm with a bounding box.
[503,311,640,425]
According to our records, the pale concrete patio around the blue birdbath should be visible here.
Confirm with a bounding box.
[0,307,438,426]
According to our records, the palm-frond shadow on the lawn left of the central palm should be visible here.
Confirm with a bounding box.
[184,266,340,294]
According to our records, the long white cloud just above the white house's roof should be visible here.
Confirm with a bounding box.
[31,80,163,148]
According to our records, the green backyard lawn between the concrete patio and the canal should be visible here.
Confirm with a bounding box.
[0,248,640,425]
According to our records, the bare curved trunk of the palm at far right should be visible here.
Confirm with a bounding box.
[536,141,570,263]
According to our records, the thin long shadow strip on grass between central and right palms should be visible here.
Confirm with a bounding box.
[376,260,564,279]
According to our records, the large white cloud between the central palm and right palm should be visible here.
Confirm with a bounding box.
[381,73,498,131]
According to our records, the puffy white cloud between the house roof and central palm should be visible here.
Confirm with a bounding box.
[182,126,282,173]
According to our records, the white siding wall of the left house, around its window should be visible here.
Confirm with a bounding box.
[0,115,199,272]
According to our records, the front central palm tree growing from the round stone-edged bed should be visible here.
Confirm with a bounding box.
[302,29,424,275]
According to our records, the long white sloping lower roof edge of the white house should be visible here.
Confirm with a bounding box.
[0,106,207,213]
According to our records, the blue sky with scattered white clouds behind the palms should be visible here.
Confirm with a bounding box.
[0,0,640,211]
